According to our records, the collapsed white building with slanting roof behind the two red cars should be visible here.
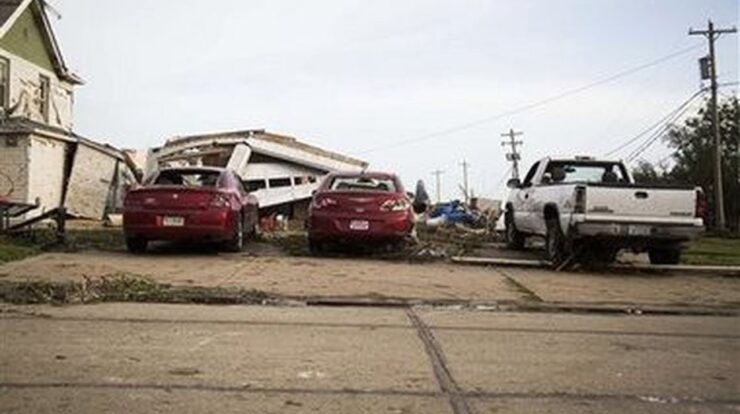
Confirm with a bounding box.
[152,129,368,221]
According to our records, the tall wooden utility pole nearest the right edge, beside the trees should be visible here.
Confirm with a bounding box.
[689,20,737,233]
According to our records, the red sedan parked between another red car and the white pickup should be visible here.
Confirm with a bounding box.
[308,172,414,252]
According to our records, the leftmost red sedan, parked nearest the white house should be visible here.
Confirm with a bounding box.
[123,167,258,253]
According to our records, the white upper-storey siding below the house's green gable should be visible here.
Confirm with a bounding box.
[0,49,74,131]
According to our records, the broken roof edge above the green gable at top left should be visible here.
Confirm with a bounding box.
[0,0,83,85]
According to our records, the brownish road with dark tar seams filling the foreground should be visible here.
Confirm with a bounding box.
[0,303,740,414]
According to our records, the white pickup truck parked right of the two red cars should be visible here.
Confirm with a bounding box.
[504,157,705,265]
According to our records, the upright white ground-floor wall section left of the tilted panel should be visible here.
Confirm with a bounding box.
[27,135,68,212]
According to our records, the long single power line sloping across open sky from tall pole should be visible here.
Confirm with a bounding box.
[356,44,702,155]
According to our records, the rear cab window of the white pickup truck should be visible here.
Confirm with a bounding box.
[543,162,628,184]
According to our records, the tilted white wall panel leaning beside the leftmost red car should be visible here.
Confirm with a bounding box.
[65,143,118,219]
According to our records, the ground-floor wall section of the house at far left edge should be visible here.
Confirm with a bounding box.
[0,135,29,201]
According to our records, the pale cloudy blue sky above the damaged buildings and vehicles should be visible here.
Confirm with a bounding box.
[52,0,738,201]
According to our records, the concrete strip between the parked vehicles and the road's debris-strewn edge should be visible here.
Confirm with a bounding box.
[0,252,740,310]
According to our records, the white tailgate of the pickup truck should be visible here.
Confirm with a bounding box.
[586,185,696,222]
